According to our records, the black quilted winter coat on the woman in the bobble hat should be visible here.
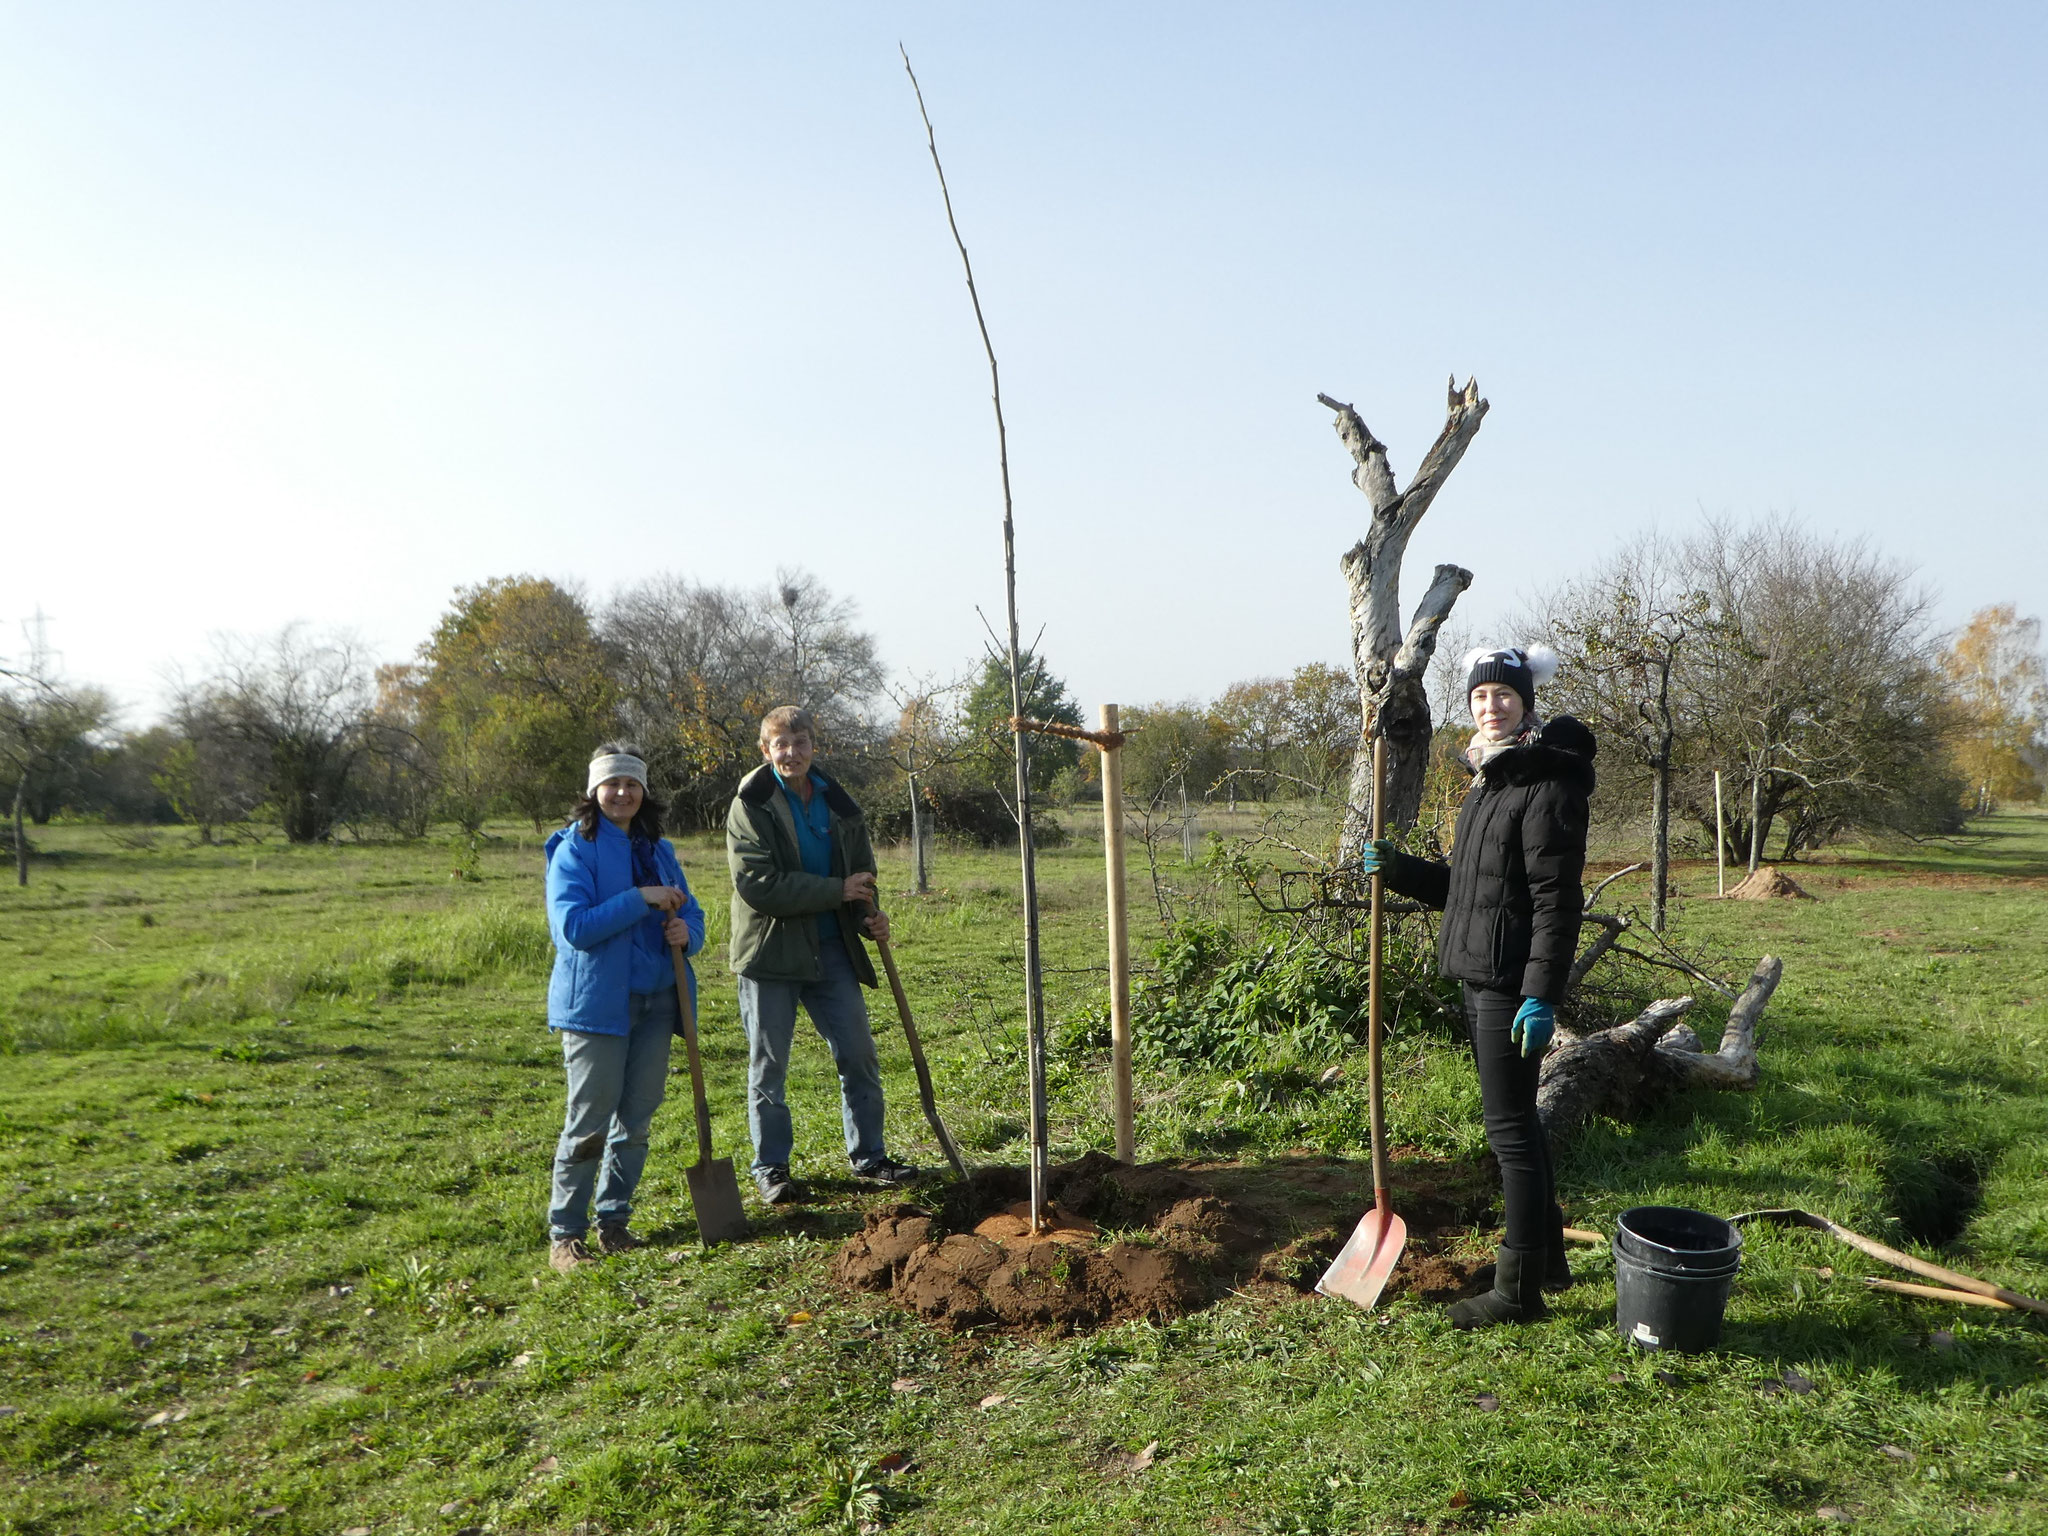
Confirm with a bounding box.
[1382,715,1597,1004]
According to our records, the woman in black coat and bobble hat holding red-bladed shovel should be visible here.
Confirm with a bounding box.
[1364,645,1595,1327]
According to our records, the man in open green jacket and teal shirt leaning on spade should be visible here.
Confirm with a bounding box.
[725,705,918,1204]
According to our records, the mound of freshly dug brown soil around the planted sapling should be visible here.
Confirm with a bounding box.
[831,1153,1499,1333]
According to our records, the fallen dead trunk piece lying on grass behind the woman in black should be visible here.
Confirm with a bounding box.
[1536,954,1784,1139]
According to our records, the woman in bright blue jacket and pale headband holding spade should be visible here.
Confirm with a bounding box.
[547,741,705,1272]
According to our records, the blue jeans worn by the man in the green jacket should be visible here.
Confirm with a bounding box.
[739,940,883,1169]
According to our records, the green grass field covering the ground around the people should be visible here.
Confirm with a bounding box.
[0,817,2048,1536]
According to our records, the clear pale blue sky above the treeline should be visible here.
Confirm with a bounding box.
[0,0,2048,721]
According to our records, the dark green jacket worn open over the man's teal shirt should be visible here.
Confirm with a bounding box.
[725,762,877,987]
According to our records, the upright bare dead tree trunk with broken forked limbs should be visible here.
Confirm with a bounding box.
[1317,379,1487,862]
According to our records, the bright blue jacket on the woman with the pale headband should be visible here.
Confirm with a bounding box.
[547,819,705,1034]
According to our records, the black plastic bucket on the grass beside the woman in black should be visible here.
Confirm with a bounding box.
[1614,1206,1743,1354]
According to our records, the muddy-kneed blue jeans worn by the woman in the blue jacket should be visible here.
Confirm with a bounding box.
[547,987,680,1239]
